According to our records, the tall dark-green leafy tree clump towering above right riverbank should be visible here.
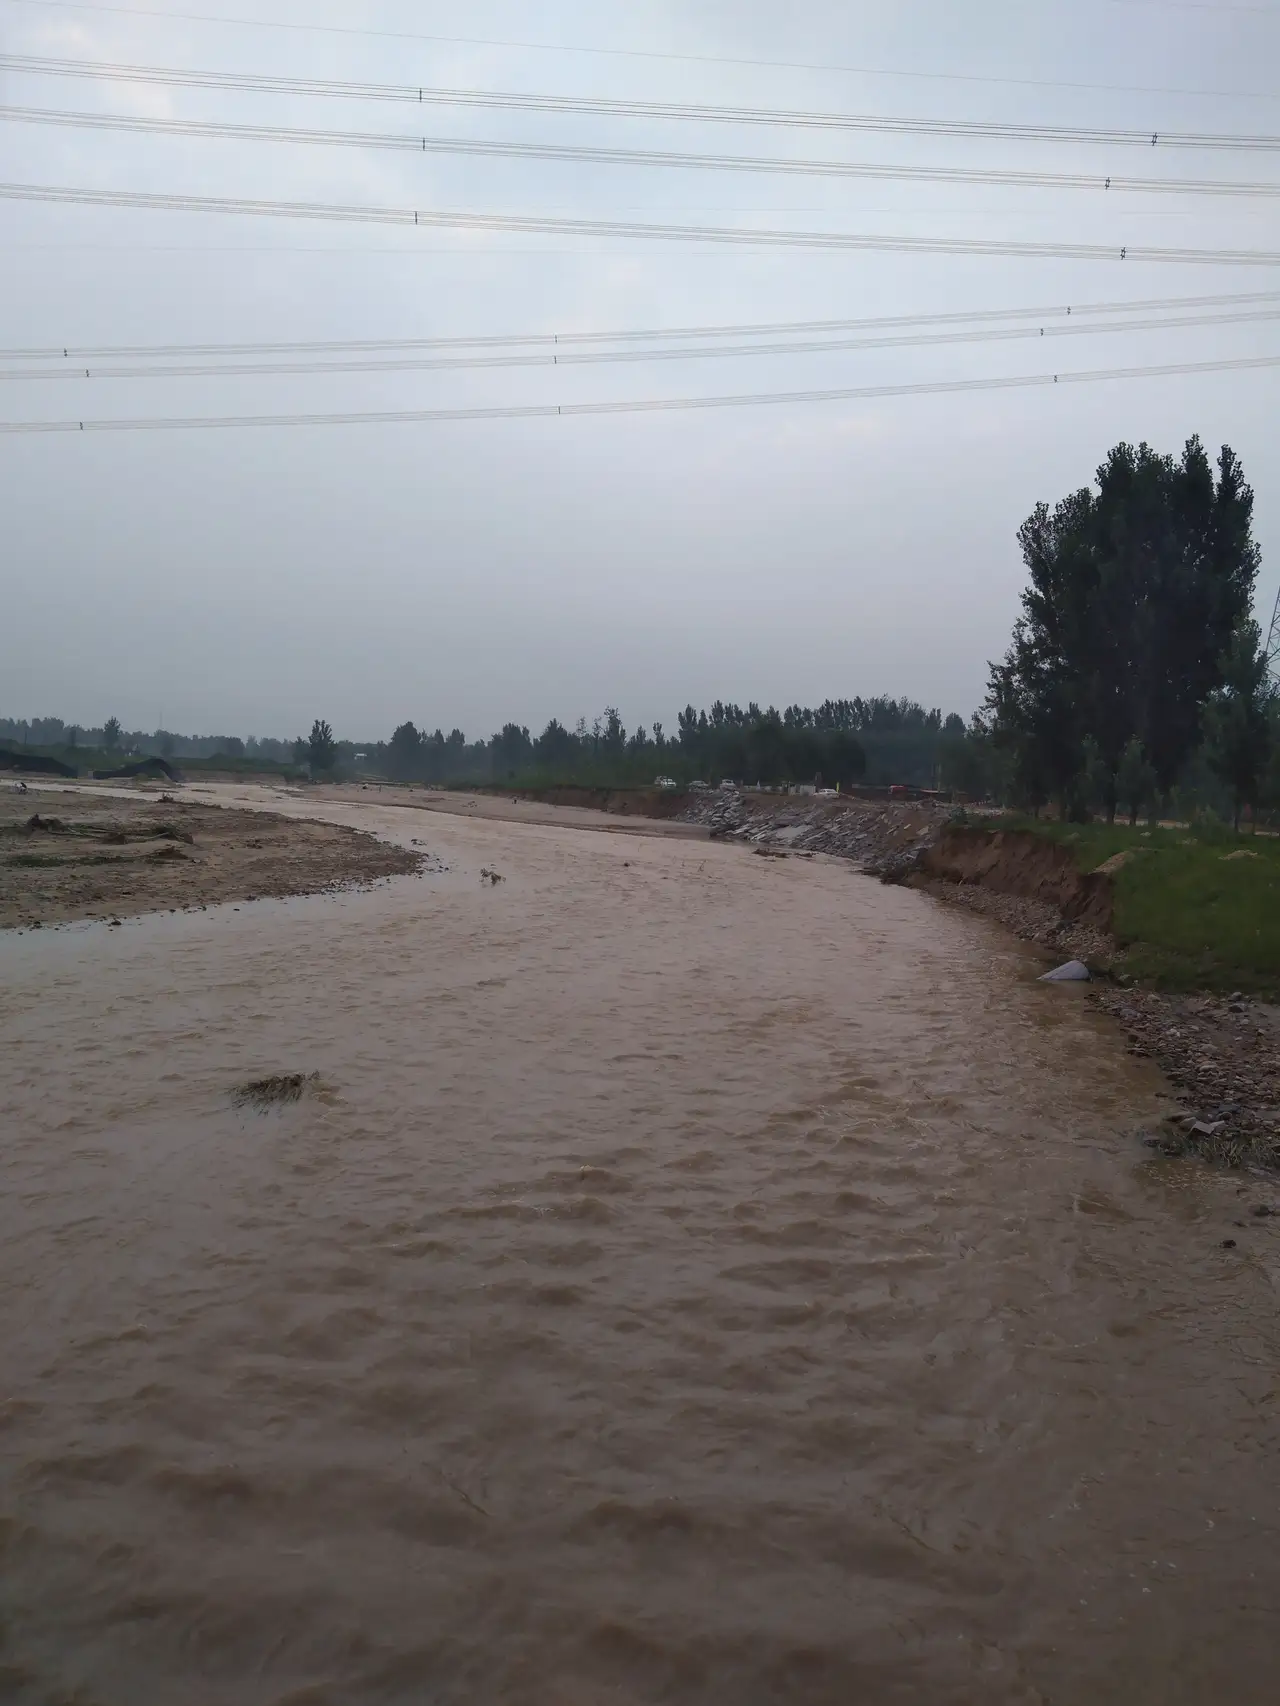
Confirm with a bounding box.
[986,438,1260,815]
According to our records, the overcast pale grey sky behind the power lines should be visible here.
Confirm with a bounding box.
[0,0,1280,739]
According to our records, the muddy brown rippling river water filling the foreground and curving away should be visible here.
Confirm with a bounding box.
[0,791,1280,1706]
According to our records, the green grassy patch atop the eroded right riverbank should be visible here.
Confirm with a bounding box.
[1021,822,1280,1000]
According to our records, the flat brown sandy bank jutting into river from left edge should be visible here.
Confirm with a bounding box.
[0,788,423,928]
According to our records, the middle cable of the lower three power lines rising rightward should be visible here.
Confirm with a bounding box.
[0,307,1280,384]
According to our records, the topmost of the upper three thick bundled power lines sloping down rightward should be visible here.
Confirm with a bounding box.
[0,53,1280,154]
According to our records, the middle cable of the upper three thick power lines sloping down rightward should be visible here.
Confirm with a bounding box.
[12,106,1280,198]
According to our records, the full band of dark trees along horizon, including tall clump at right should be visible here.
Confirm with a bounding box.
[0,438,1280,822]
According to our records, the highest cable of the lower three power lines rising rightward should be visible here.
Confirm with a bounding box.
[0,290,1280,362]
